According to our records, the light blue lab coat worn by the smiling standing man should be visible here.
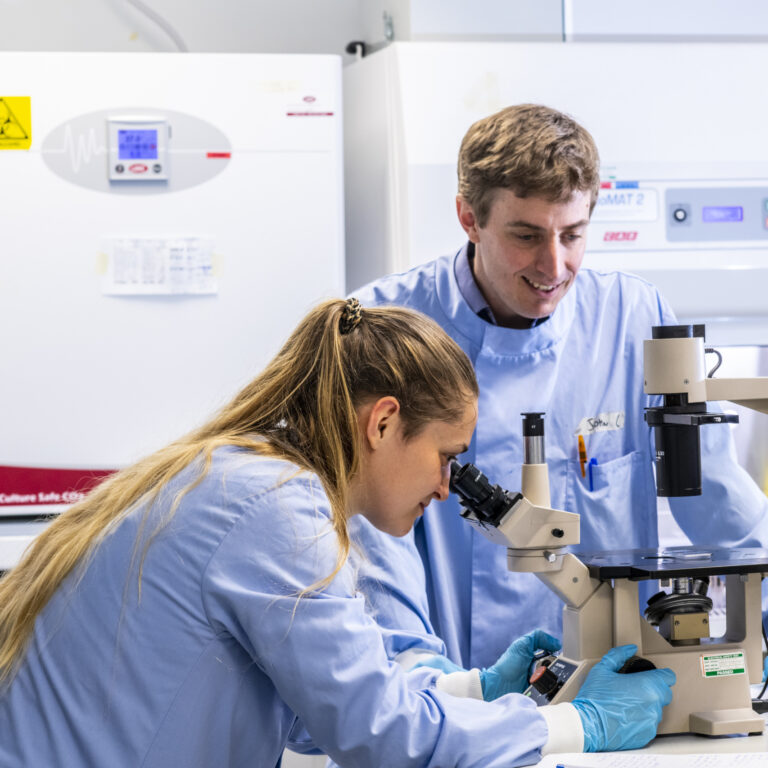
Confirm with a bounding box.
[354,246,768,667]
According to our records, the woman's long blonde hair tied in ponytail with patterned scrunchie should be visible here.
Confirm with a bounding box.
[0,300,477,681]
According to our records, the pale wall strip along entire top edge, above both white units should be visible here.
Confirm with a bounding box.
[6,0,768,62]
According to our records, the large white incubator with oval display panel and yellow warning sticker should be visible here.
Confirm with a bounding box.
[0,53,344,514]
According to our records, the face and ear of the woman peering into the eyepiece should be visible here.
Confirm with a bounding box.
[352,397,477,536]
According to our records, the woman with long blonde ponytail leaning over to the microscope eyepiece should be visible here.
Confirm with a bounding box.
[0,300,672,768]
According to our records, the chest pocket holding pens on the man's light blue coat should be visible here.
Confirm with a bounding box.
[565,451,658,552]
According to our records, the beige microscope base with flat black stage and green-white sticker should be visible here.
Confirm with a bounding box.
[527,547,768,736]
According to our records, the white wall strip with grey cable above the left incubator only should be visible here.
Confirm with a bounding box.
[0,0,364,55]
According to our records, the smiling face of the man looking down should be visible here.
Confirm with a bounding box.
[456,189,591,328]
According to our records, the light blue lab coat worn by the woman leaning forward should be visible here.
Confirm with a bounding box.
[0,448,548,768]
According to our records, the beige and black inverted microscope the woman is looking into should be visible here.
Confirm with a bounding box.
[451,325,768,736]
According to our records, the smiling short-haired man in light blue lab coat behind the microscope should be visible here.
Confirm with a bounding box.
[340,104,768,680]
